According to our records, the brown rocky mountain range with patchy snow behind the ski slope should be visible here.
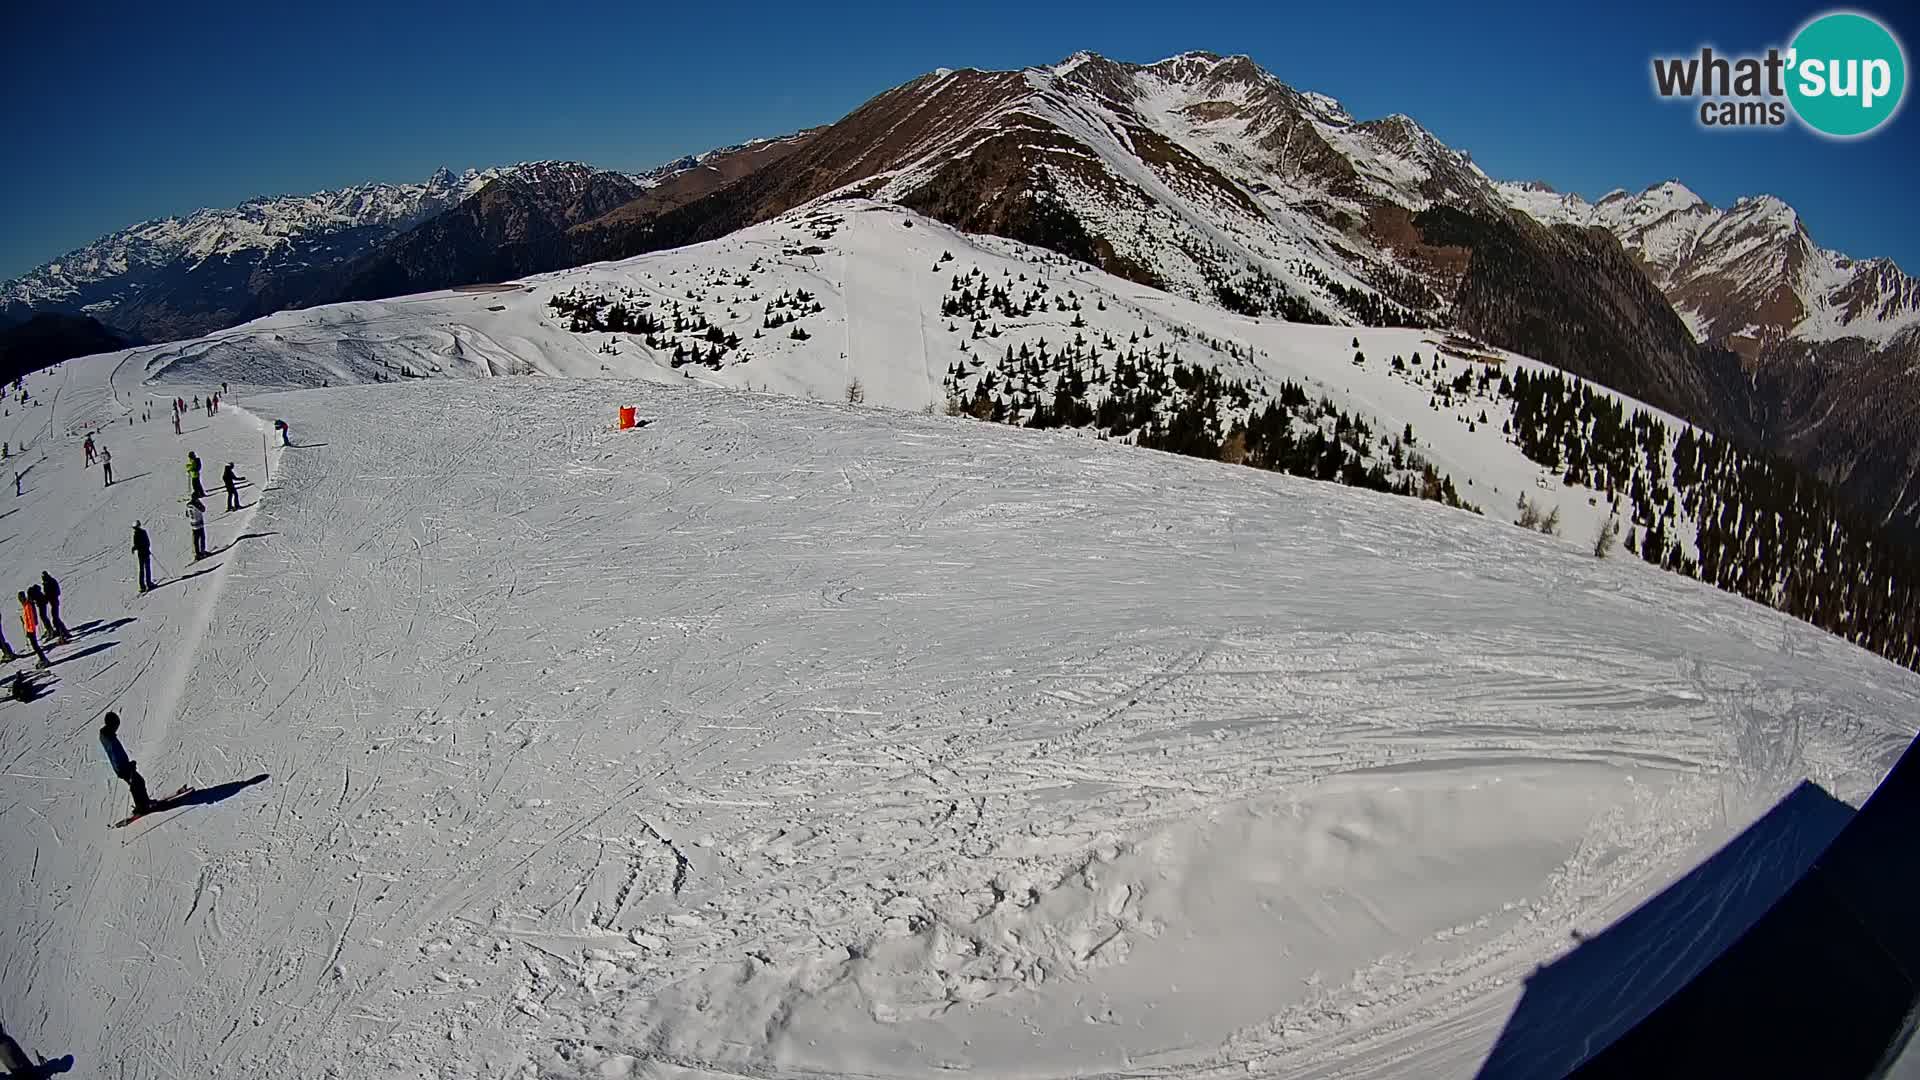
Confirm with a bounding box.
[0,52,1920,530]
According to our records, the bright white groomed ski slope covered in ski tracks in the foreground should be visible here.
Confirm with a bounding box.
[0,223,1920,1080]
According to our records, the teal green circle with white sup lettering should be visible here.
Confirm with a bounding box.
[1788,12,1907,138]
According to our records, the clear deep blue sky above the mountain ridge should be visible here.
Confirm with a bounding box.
[0,0,1920,279]
